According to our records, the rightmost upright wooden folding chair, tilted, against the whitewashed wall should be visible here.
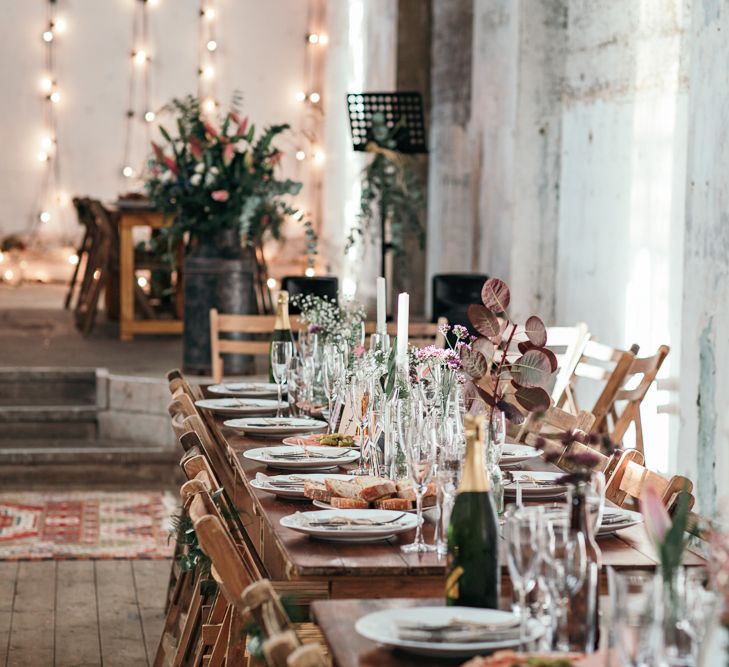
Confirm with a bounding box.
[609,345,670,455]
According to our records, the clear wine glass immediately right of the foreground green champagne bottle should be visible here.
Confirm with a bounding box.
[504,505,544,650]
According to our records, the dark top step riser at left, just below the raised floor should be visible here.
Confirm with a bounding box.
[0,367,96,406]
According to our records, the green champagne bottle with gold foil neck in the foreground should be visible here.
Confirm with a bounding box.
[446,415,501,609]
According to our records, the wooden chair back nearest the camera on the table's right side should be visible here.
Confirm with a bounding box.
[605,457,695,512]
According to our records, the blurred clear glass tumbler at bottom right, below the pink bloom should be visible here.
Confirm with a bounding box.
[608,567,661,667]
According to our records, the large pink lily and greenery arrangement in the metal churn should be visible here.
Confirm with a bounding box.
[146,96,316,256]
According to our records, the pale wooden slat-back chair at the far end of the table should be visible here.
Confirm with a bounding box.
[210,308,300,382]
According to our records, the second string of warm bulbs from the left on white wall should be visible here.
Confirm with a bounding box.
[121,0,159,179]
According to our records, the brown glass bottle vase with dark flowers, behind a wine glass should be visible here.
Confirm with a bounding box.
[567,482,602,653]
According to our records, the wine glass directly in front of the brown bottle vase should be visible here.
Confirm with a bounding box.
[544,519,587,651]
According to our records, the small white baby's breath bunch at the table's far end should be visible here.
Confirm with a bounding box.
[291,294,367,352]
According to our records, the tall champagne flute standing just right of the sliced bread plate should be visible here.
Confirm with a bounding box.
[397,400,436,553]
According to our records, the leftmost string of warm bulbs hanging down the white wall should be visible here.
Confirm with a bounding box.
[29,0,68,244]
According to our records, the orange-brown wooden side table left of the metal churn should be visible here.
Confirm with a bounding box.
[118,206,182,342]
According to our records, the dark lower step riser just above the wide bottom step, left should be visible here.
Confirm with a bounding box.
[0,405,98,446]
